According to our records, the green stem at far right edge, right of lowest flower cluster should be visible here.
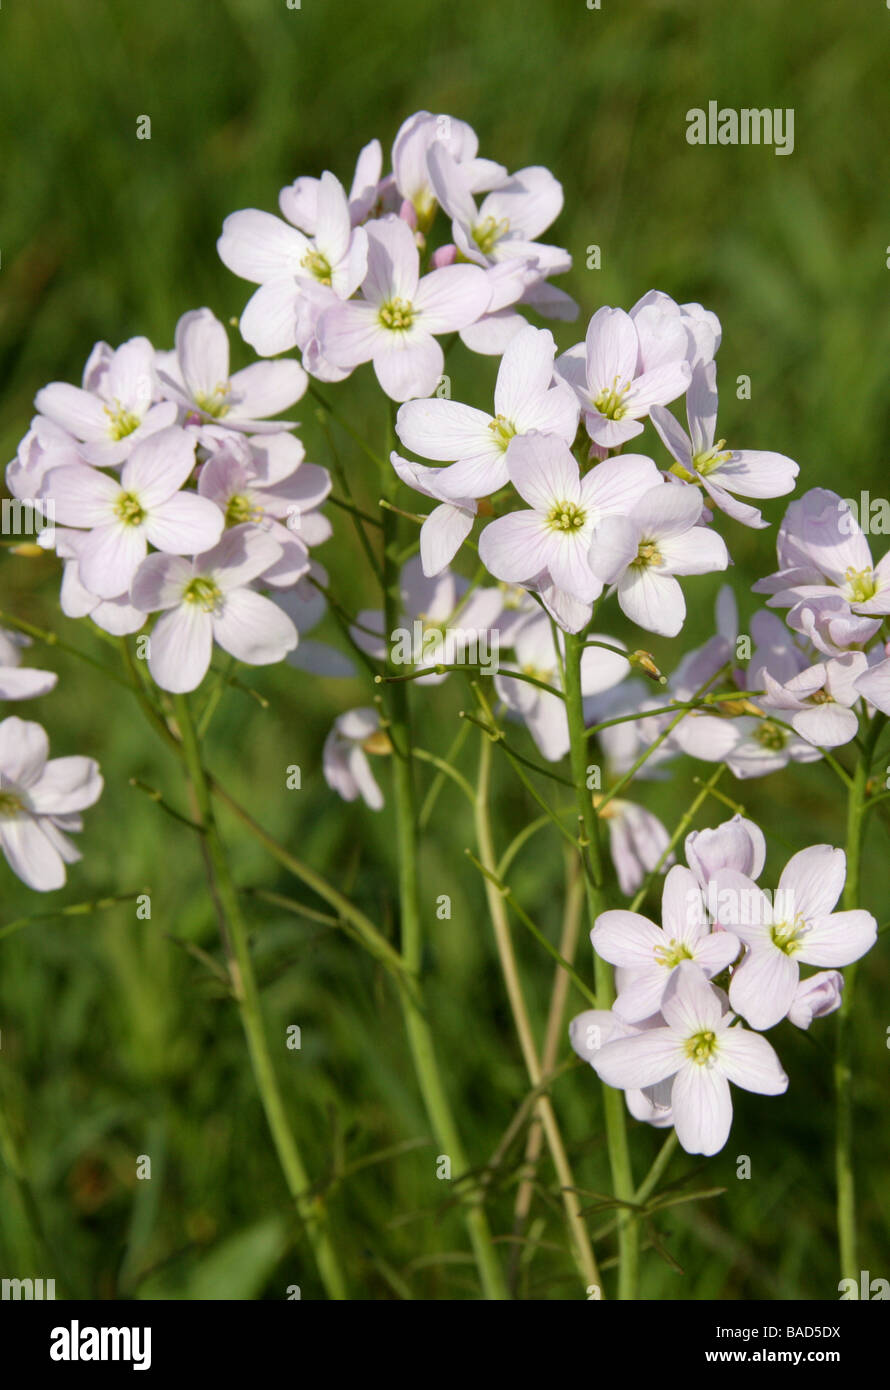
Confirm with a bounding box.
[834,714,884,1287]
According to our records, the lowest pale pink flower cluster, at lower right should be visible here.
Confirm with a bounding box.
[570,816,877,1154]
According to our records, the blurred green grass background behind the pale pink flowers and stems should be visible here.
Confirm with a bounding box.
[0,0,890,1300]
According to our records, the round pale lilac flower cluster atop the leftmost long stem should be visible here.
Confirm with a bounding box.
[7,309,331,691]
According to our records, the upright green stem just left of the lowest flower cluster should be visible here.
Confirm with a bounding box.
[565,634,640,1301]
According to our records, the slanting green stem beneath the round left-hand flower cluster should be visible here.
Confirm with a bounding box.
[175,695,348,1300]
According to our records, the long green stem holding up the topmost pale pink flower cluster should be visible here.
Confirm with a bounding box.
[384,509,509,1300]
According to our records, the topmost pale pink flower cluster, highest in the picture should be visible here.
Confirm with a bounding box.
[218,111,577,400]
